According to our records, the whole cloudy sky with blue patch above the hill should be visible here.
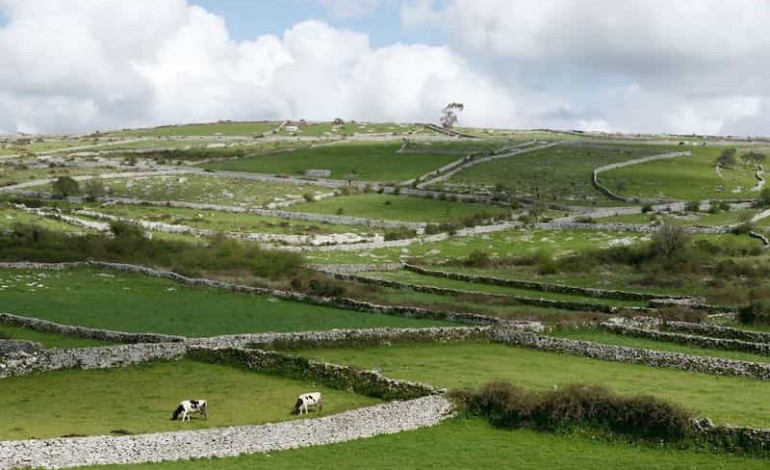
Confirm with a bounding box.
[0,0,770,136]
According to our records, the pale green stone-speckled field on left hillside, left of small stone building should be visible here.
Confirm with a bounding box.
[104,175,328,206]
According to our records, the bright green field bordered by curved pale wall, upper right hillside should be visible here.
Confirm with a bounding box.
[601,146,759,201]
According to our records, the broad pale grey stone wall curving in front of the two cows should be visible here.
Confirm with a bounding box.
[0,395,452,469]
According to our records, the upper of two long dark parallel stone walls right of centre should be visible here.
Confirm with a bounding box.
[404,264,690,301]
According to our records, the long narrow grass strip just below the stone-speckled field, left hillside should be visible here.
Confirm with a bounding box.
[81,204,370,235]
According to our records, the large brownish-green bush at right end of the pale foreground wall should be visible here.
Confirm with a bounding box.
[453,382,691,441]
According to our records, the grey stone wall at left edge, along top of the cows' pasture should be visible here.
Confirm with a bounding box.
[0,343,187,378]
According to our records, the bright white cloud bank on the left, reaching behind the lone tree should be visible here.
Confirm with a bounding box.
[0,0,515,133]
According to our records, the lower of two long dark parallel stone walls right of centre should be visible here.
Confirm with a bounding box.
[334,273,650,313]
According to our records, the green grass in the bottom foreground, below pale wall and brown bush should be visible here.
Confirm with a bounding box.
[81,419,767,470]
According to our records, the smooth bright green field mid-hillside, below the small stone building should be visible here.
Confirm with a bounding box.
[288,194,509,223]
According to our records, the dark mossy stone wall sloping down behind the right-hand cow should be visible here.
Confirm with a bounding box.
[188,348,443,400]
